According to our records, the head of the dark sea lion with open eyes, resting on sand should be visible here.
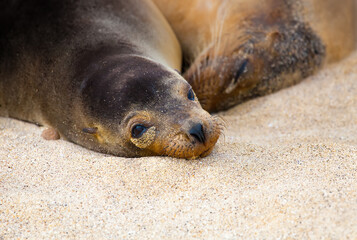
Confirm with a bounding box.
[77,54,222,159]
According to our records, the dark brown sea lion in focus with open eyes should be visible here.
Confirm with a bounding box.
[0,0,222,159]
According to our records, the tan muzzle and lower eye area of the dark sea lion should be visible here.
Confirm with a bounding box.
[120,105,222,159]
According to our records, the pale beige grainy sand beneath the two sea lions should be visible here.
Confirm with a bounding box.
[0,49,357,239]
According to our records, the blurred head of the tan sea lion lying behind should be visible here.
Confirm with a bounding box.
[184,0,325,112]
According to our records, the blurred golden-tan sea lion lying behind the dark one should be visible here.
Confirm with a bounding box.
[154,0,356,112]
